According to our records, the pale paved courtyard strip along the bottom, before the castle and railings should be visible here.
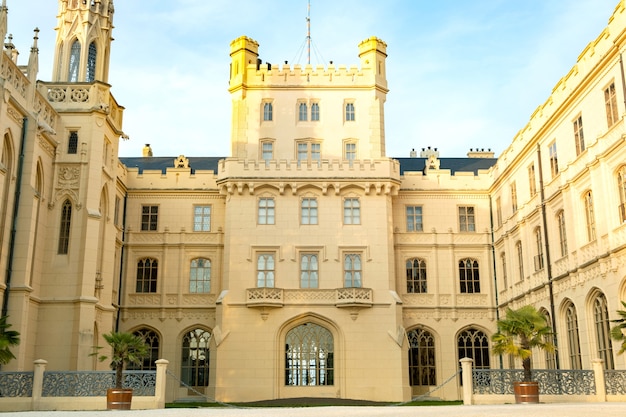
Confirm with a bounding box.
[1,403,626,417]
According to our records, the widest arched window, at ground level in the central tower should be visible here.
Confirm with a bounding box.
[285,323,335,386]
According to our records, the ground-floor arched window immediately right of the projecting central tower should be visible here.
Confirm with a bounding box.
[407,329,437,386]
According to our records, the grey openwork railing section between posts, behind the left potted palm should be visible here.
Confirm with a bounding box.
[42,371,156,397]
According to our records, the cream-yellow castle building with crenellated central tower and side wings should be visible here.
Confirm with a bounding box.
[0,0,626,402]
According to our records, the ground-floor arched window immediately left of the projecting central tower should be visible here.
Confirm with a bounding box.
[180,328,211,387]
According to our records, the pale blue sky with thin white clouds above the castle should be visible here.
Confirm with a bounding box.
[6,0,619,157]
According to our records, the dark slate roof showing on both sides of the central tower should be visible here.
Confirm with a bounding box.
[120,156,498,175]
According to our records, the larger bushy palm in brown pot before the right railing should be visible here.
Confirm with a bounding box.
[491,305,555,403]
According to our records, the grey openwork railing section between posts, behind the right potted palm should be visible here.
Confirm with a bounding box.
[472,369,596,395]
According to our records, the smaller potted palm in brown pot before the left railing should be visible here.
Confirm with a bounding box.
[94,332,150,410]
